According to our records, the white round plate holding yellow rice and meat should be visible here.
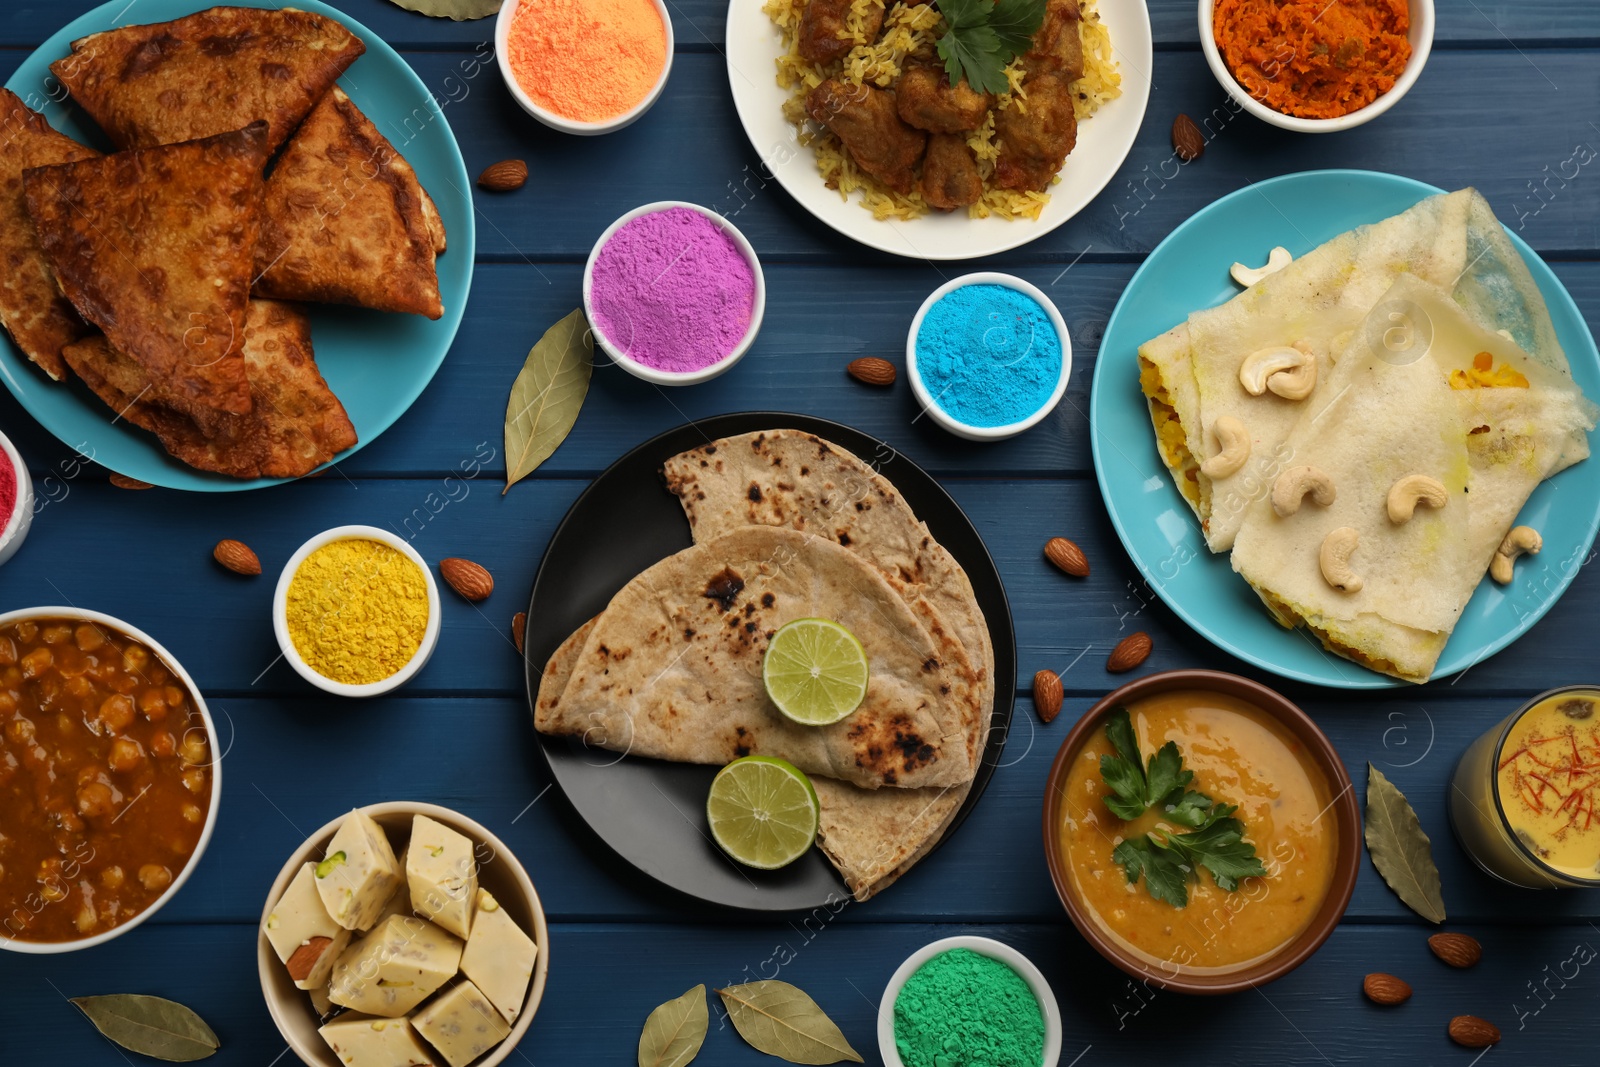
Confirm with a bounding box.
[726,0,1150,259]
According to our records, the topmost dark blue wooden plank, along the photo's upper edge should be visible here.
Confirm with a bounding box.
[0,0,1600,51]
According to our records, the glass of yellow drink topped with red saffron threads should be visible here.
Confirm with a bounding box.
[1450,685,1600,889]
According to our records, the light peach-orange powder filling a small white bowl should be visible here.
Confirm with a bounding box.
[506,0,667,122]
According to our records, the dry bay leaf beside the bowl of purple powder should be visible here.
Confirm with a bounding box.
[501,309,595,496]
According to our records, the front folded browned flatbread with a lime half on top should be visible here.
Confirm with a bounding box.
[534,526,979,789]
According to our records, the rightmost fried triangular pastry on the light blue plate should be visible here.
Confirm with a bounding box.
[254,86,445,318]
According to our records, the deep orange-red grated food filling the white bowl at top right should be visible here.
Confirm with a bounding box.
[1211,0,1411,118]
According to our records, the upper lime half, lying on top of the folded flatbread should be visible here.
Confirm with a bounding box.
[762,619,867,726]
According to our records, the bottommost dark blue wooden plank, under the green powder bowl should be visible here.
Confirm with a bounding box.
[0,918,1600,1067]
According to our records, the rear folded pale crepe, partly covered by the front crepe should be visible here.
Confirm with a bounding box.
[1139,189,1566,552]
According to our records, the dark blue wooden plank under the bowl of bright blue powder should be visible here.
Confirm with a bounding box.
[0,261,1600,479]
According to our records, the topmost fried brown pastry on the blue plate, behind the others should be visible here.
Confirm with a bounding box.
[50,8,366,154]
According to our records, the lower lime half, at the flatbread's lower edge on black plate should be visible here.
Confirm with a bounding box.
[706,755,818,870]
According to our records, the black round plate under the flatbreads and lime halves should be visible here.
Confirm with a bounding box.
[525,411,1016,912]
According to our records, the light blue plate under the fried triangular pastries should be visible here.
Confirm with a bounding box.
[0,0,475,493]
